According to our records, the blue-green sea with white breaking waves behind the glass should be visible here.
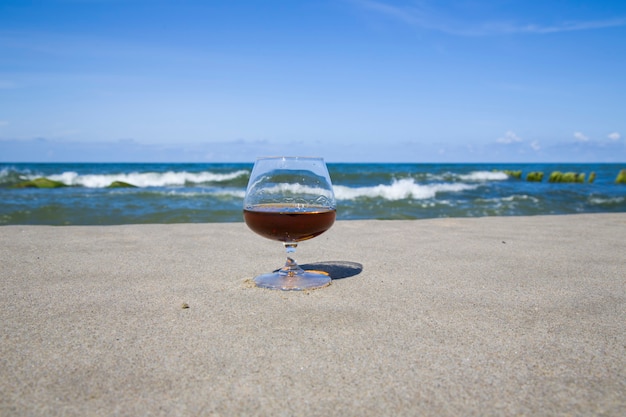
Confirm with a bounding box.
[0,163,626,225]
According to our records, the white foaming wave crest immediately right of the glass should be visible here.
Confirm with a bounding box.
[334,178,477,200]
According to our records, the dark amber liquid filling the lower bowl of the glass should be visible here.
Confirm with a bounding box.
[243,204,335,242]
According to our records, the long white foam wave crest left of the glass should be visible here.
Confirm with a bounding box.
[38,170,248,188]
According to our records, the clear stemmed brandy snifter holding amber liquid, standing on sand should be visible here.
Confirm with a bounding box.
[243,156,336,290]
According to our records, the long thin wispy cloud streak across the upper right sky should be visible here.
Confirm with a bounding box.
[352,0,626,36]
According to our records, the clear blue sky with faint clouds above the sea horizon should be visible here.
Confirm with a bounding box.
[0,0,626,162]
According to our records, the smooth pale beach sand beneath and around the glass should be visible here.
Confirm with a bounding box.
[0,214,626,416]
